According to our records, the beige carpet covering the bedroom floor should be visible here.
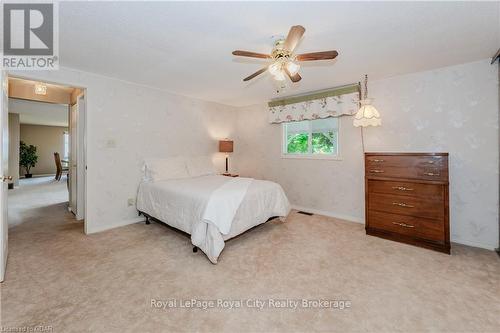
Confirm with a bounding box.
[1,180,500,332]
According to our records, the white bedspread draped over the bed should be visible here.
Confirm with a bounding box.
[137,176,290,263]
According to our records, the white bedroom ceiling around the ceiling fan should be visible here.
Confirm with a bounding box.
[59,2,500,106]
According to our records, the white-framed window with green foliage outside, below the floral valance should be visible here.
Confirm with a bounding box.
[283,118,339,158]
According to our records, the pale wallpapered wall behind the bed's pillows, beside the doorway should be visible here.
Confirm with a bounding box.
[10,68,236,233]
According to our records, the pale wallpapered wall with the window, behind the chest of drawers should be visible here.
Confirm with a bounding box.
[234,60,499,249]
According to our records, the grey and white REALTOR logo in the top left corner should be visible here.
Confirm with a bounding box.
[2,2,59,70]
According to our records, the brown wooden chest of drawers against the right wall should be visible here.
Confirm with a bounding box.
[365,153,450,253]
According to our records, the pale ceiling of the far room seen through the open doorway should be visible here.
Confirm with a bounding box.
[9,98,69,127]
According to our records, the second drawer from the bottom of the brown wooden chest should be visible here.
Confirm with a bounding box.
[368,193,444,219]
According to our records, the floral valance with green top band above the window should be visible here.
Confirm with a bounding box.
[268,84,359,124]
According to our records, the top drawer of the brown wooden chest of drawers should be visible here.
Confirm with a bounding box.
[365,155,448,181]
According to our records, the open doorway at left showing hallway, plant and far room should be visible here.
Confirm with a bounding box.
[0,76,86,278]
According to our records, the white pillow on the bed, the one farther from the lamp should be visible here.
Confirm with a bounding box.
[144,157,189,181]
